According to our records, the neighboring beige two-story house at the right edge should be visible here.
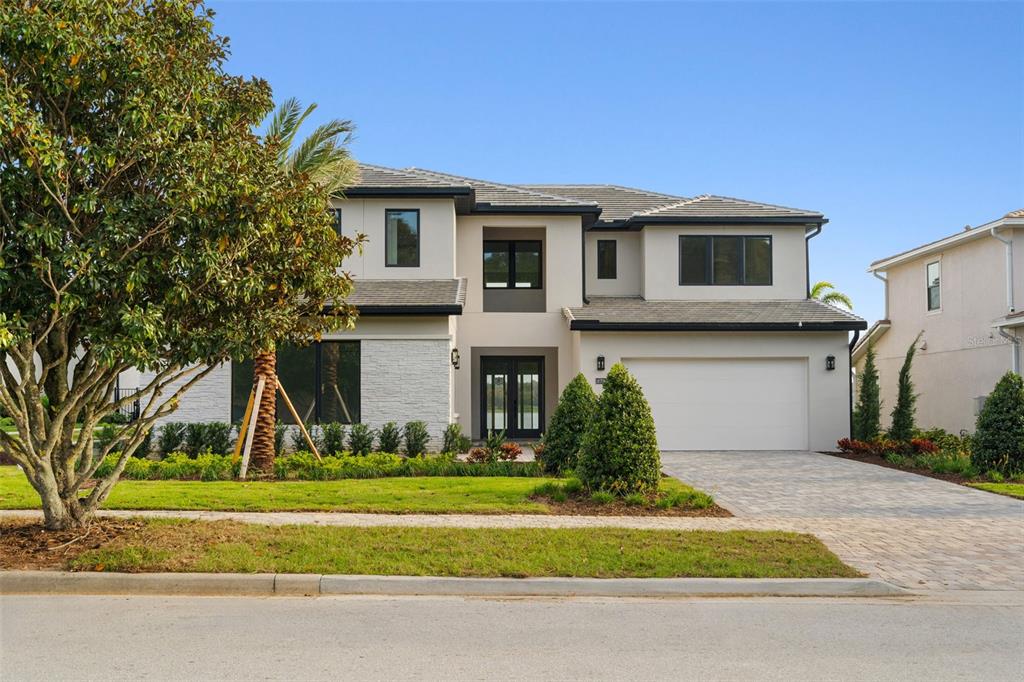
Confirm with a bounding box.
[853,209,1024,433]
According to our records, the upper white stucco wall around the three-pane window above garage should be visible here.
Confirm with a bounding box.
[642,225,807,300]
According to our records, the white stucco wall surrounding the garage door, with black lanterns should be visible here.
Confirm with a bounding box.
[572,332,850,450]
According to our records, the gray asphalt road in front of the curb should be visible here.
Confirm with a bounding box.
[0,592,1024,682]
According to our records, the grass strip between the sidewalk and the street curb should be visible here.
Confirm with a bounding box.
[59,520,860,578]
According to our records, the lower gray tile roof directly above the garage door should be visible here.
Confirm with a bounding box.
[565,296,867,331]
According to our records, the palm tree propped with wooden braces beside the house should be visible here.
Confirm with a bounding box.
[251,97,357,471]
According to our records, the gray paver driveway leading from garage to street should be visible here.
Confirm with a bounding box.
[662,452,1024,590]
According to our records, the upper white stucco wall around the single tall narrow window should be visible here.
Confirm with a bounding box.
[334,199,455,280]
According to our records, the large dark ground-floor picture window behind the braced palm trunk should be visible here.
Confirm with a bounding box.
[231,341,359,424]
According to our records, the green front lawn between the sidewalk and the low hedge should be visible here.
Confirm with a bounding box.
[0,467,704,514]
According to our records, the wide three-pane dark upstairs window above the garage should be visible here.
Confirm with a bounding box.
[679,235,772,286]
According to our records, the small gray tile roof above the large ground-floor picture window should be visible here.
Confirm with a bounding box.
[346,278,466,314]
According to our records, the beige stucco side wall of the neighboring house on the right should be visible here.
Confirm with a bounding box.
[857,230,1024,433]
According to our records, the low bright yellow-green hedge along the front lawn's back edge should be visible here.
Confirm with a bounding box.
[96,452,544,480]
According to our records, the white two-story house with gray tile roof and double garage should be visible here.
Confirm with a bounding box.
[153,165,866,450]
